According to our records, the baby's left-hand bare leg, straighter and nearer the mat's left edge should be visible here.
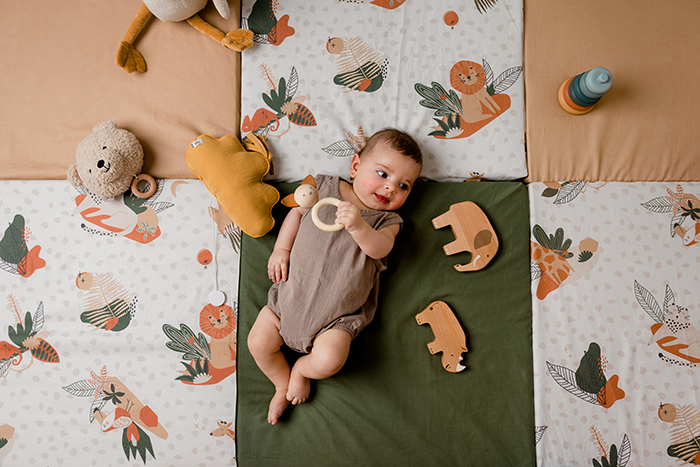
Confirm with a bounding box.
[248,306,290,425]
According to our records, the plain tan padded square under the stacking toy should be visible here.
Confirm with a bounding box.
[524,0,700,181]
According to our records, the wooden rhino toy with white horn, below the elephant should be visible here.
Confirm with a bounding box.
[416,301,468,373]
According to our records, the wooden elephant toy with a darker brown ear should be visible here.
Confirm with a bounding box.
[433,201,498,272]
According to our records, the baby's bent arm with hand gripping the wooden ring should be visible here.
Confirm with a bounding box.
[336,201,399,259]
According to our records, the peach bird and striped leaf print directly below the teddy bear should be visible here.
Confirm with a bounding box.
[80,273,137,332]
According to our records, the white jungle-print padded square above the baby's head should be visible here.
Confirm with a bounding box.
[241,0,526,181]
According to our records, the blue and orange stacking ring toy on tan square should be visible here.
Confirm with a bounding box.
[557,67,612,115]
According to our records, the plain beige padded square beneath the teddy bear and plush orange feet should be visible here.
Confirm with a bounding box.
[0,0,240,179]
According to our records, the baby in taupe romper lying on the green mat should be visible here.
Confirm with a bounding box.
[248,128,422,425]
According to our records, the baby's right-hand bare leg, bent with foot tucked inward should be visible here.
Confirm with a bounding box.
[287,329,352,405]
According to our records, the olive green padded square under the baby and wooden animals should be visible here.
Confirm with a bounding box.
[236,182,535,467]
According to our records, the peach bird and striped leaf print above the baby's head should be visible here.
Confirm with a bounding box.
[326,37,388,92]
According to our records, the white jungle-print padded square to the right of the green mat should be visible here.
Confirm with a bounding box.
[528,181,700,467]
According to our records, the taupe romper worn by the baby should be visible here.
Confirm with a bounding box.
[268,175,403,353]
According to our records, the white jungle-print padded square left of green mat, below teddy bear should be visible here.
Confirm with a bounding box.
[0,180,240,466]
